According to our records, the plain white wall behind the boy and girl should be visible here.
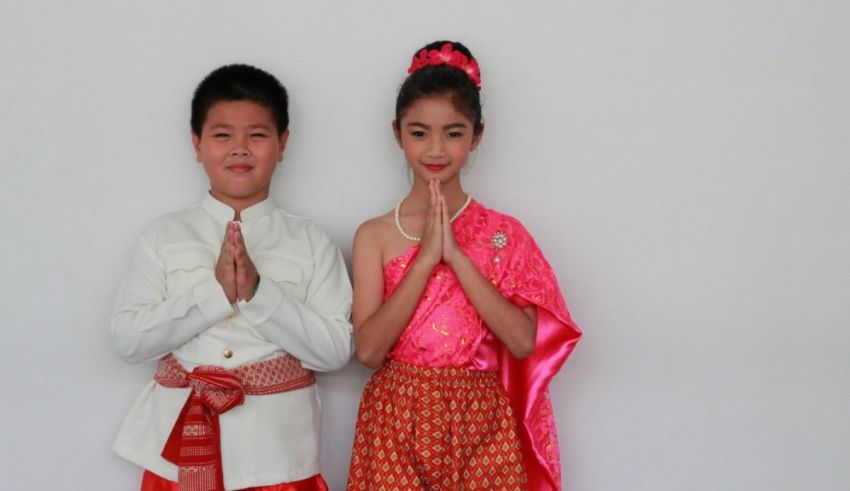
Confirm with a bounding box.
[0,0,850,491]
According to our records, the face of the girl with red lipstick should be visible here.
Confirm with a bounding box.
[393,96,482,184]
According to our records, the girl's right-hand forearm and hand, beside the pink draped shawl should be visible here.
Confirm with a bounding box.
[440,195,537,360]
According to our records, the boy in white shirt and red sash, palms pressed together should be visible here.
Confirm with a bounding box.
[111,65,352,491]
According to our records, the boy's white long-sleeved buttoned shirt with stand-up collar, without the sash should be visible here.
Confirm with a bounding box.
[111,194,353,489]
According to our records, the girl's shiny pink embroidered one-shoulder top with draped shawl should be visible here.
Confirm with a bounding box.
[384,200,581,491]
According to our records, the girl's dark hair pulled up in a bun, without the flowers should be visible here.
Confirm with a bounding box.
[395,41,484,133]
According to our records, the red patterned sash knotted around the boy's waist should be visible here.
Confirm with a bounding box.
[154,353,316,491]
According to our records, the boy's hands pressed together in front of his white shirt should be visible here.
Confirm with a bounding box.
[215,222,260,303]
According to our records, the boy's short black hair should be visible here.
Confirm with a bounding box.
[190,64,289,136]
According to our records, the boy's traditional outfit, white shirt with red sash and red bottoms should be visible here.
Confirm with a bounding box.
[111,194,352,491]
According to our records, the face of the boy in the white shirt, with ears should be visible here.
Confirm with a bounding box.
[192,101,289,210]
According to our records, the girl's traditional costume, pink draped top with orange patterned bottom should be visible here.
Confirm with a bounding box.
[348,200,581,491]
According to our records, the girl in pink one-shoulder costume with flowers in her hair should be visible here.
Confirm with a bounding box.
[348,41,581,490]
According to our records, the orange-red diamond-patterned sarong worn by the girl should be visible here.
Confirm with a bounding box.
[348,361,528,491]
